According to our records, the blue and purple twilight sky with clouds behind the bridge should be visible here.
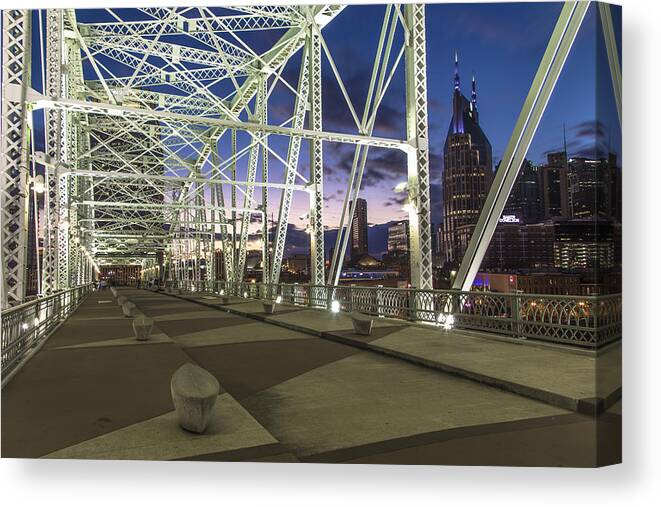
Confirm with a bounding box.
[33,3,621,258]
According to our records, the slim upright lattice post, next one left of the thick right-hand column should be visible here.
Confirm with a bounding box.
[308,23,326,285]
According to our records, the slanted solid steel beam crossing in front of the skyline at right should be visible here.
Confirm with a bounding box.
[452,2,590,290]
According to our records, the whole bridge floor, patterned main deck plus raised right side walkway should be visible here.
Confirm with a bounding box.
[2,288,621,466]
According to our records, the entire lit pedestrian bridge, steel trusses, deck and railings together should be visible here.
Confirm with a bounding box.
[0,2,621,466]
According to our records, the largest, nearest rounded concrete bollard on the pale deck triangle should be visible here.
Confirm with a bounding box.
[170,363,220,433]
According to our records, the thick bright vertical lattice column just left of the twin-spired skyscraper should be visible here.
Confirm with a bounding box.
[404,4,432,289]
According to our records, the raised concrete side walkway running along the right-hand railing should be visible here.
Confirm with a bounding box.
[177,293,622,414]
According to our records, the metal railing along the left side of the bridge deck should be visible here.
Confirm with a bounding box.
[2,284,93,386]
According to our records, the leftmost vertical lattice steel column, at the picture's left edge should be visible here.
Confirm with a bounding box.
[0,9,31,308]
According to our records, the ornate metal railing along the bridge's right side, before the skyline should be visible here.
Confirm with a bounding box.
[164,281,622,349]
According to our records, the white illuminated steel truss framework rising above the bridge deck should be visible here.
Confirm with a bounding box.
[1,2,619,307]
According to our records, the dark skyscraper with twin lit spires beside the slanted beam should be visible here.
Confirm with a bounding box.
[440,54,493,266]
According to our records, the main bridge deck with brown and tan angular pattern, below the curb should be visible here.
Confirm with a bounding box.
[2,289,619,466]
